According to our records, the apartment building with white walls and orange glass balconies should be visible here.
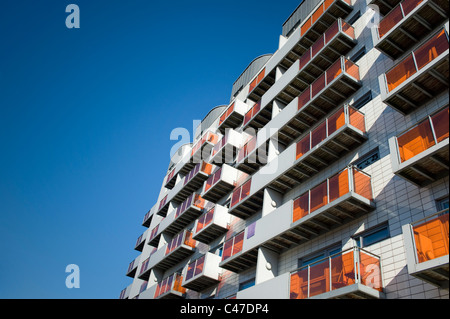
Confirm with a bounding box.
[120,0,449,299]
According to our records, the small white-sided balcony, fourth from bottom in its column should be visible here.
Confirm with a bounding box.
[209,129,243,165]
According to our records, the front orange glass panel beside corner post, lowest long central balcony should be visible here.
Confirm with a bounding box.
[331,251,355,290]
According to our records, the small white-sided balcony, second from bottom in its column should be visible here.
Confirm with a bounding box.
[192,205,230,244]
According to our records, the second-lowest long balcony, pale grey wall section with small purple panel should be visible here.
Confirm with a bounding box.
[220,166,375,272]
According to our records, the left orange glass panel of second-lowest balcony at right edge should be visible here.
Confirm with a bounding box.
[397,120,435,163]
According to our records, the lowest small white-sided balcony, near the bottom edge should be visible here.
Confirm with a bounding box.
[182,253,222,291]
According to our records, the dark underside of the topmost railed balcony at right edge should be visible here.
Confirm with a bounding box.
[375,0,449,60]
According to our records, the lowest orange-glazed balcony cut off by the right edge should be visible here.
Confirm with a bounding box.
[403,208,449,289]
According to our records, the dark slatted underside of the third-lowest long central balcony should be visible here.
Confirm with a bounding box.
[268,126,367,193]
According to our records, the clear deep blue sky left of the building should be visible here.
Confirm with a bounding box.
[0,0,300,298]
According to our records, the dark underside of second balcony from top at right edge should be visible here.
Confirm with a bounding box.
[383,50,449,115]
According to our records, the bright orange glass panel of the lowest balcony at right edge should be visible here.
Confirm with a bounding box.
[413,212,449,263]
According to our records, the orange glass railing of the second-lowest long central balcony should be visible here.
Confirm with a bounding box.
[292,167,373,223]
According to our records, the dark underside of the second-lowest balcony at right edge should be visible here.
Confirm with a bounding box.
[394,139,450,187]
